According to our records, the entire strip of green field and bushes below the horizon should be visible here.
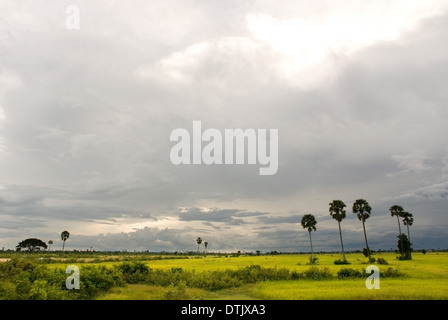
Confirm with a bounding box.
[0,251,448,300]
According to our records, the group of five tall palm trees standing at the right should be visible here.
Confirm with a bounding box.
[301,199,414,261]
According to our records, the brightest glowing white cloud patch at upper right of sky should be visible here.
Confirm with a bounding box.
[246,0,448,88]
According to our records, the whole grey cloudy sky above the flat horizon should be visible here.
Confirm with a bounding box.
[0,0,448,251]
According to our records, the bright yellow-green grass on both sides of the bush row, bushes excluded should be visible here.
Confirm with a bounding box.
[1,252,448,300]
